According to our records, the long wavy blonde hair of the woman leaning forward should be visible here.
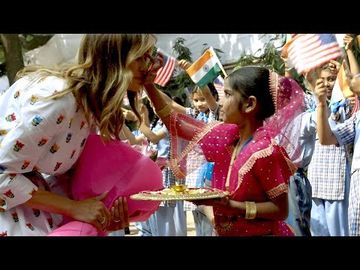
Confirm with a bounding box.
[18,34,155,140]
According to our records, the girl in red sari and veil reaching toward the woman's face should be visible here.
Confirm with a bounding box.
[145,67,304,236]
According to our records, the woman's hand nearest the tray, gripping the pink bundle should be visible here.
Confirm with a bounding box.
[106,197,129,231]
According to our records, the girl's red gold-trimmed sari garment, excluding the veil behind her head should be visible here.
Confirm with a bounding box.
[170,114,296,236]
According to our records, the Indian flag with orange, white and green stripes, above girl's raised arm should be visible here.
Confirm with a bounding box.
[186,47,223,87]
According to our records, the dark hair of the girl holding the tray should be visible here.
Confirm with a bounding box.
[228,66,275,121]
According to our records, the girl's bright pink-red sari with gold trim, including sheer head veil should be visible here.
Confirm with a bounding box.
[165,73,304,236]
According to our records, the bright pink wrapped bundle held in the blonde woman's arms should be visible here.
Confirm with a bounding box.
[50,134,163,236]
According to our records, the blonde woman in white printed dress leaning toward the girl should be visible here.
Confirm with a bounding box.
[0,34,155,236]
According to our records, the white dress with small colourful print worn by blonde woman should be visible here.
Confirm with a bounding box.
[0,76,89,236]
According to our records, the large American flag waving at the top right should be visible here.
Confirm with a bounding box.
[288,34,342,74]
